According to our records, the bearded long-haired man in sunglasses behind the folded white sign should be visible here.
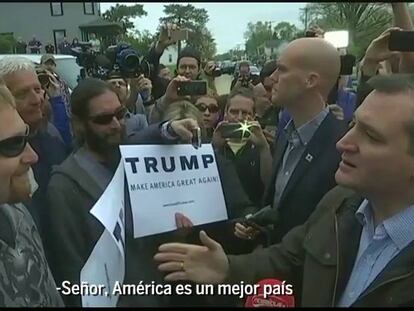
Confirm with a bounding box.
[45,79,198,306]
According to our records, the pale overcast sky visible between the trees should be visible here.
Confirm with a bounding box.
[101,2,305,54]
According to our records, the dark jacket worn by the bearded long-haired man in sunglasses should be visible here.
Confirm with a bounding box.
[45,156,165,307]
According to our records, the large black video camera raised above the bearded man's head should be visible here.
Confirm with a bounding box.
[72,42,151,80]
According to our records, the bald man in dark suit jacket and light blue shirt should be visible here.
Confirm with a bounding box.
[235,38,347,243]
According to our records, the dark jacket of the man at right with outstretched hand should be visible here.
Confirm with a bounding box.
[225,187,414,307]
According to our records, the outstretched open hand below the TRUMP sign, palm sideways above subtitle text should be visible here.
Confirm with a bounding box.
[154,231,229,284]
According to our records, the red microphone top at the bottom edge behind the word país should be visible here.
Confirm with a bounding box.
[244,279,295,308]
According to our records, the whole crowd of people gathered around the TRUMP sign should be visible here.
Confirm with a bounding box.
[0,3,414,307]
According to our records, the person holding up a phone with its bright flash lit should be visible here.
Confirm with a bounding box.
[212,88,272,205]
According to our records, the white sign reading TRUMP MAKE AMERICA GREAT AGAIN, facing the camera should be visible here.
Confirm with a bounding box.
[120,145,227,238]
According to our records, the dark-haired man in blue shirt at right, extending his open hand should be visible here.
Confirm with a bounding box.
[155,74,414,307]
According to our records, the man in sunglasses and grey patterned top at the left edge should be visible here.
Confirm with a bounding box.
[0,82,63,307]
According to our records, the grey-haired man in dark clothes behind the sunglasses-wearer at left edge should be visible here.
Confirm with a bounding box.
[0,56,69,243]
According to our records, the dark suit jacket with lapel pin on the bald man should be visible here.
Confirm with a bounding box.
[265,113,347,243]
